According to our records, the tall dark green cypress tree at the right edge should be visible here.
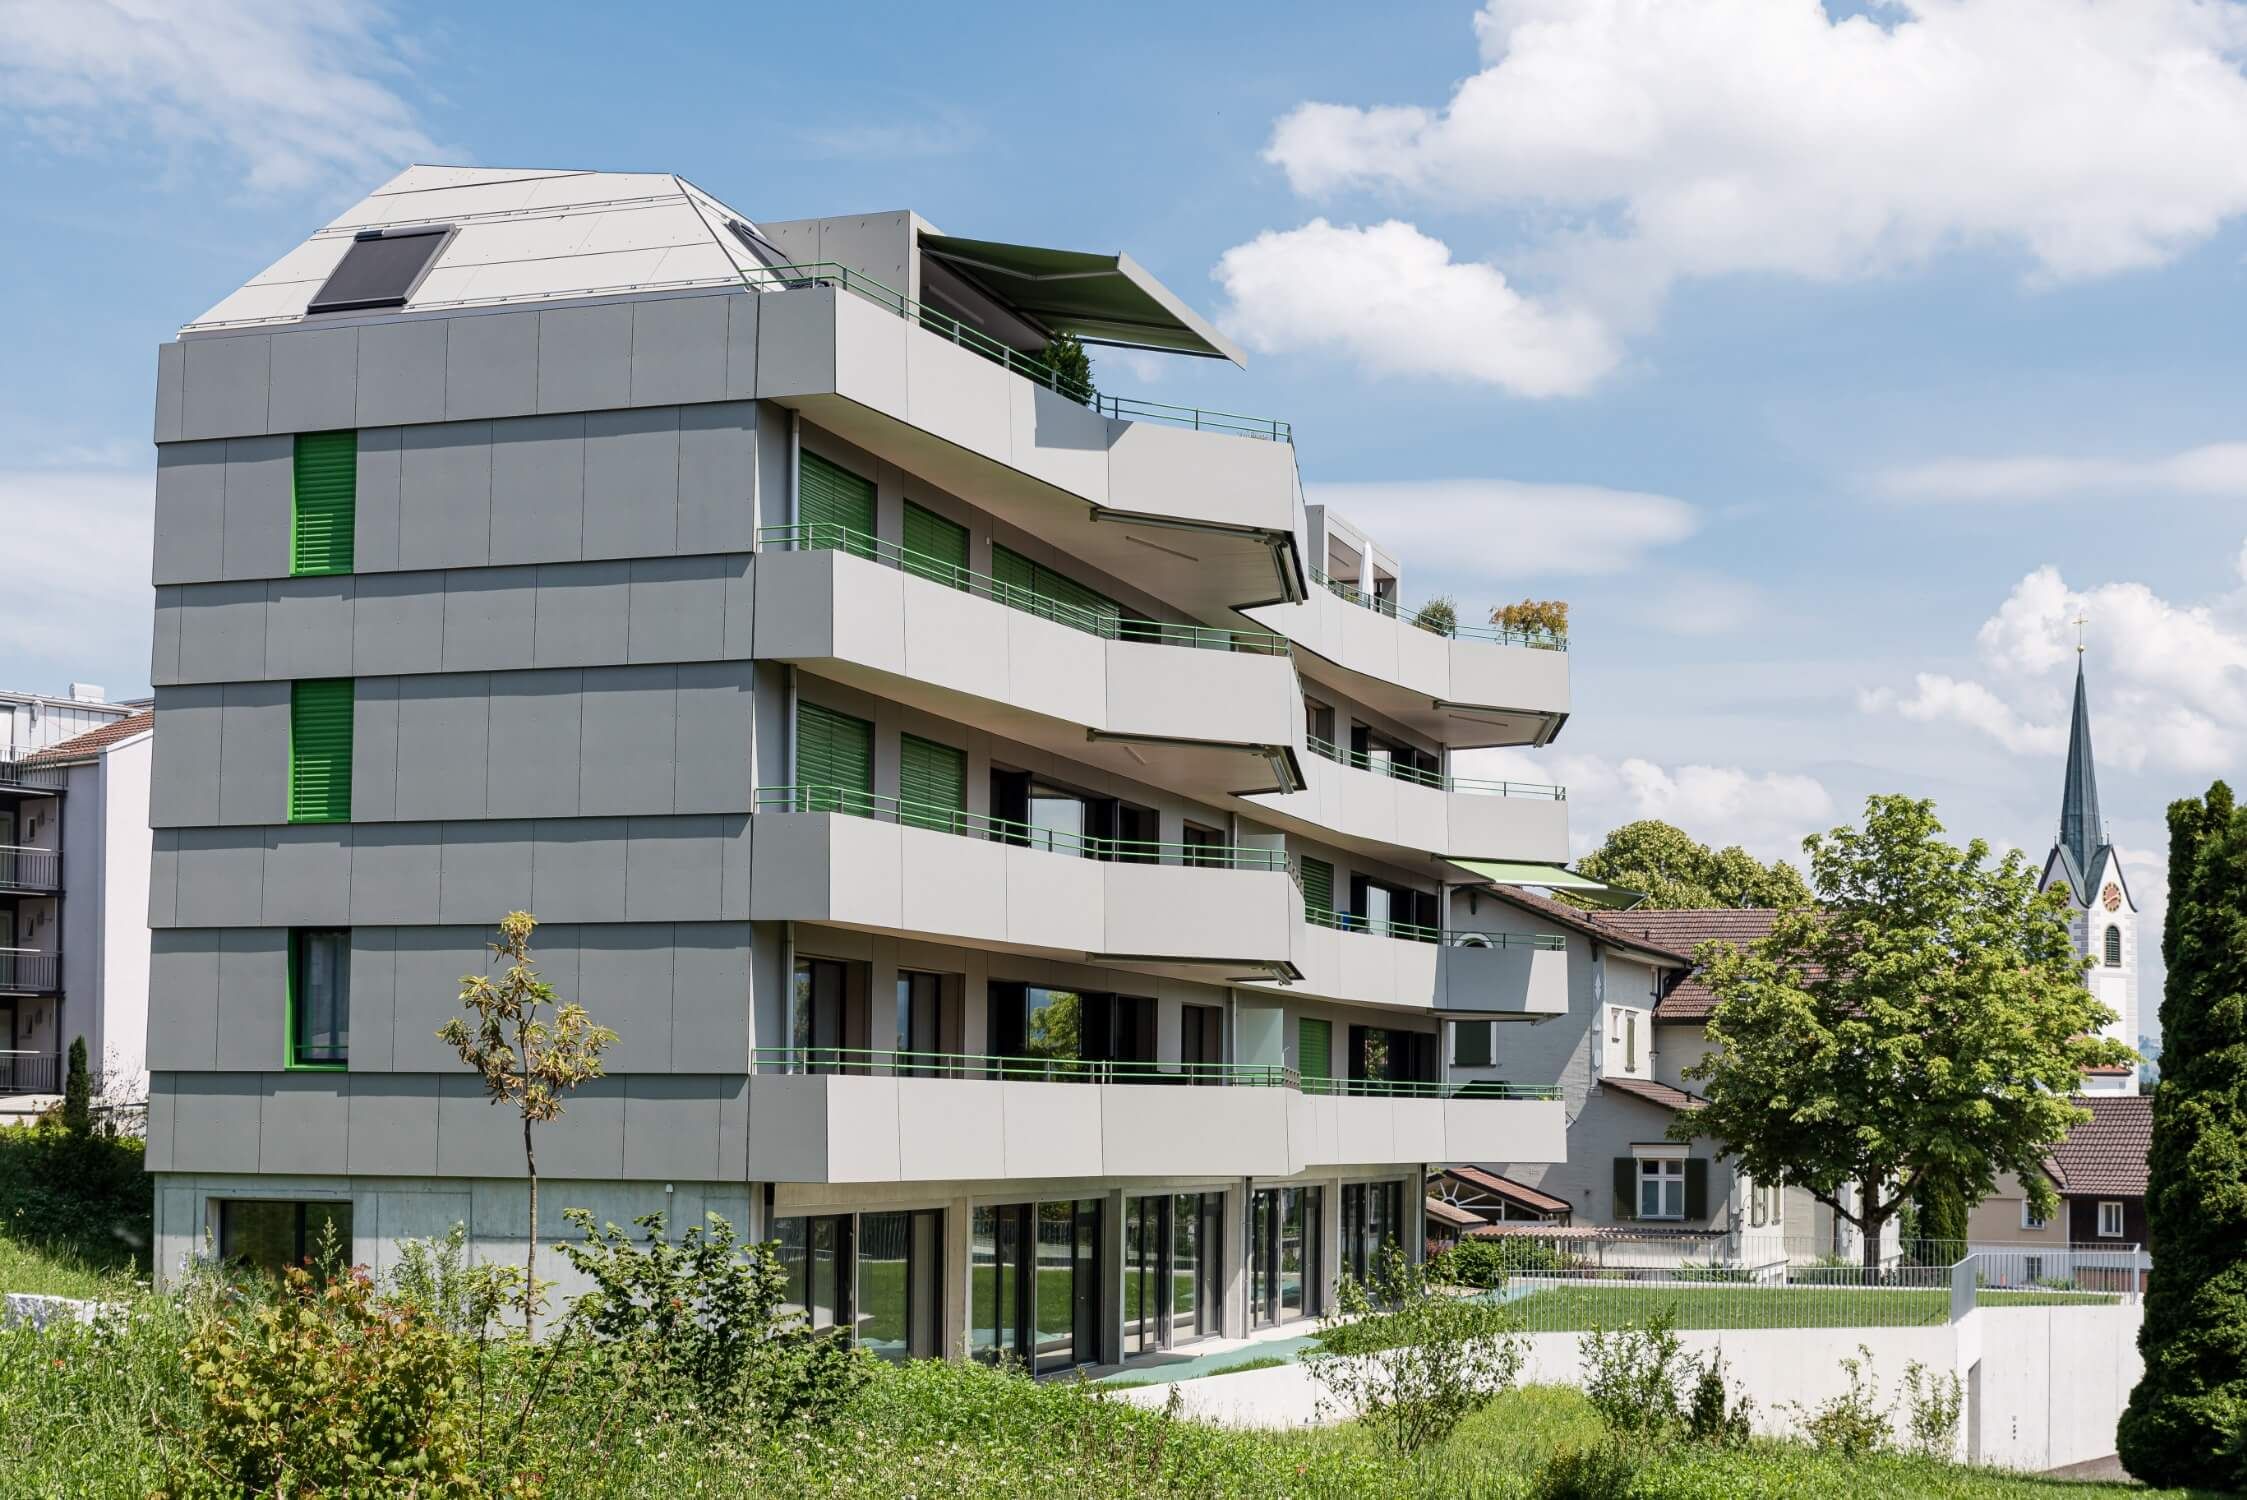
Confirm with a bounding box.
[2117,781,2247,1489]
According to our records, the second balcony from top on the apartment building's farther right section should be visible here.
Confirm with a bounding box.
[1256,737,1568,865]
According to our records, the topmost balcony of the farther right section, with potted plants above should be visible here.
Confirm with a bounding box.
[1247,570,1568,750]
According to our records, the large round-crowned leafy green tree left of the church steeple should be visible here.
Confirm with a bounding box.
[1672,797,2135,1269]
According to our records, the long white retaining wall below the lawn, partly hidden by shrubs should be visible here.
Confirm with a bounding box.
[1117,1307,2141,1471]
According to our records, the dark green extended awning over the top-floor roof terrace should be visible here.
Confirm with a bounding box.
[921,234,1245,364]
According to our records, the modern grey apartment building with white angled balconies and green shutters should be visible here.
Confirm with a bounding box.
[148,166,1571,1370]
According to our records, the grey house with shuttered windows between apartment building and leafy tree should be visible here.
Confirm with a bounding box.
[1454,885,1894,1260]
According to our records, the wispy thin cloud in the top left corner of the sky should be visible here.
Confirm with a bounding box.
[0,0,438,191]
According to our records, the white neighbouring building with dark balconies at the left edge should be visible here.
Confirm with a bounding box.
[0,683,151,1118]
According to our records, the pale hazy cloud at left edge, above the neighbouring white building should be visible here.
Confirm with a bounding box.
[0,469,155,687]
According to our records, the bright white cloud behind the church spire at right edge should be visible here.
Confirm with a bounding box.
[1858,568,2247,775]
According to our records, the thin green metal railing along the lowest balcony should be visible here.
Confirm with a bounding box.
[750,1046,1559,1100]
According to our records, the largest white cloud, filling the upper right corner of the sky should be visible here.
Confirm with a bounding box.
[1220,0,2247,395]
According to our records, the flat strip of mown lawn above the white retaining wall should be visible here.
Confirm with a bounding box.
[1510,1282,2117,1334]
